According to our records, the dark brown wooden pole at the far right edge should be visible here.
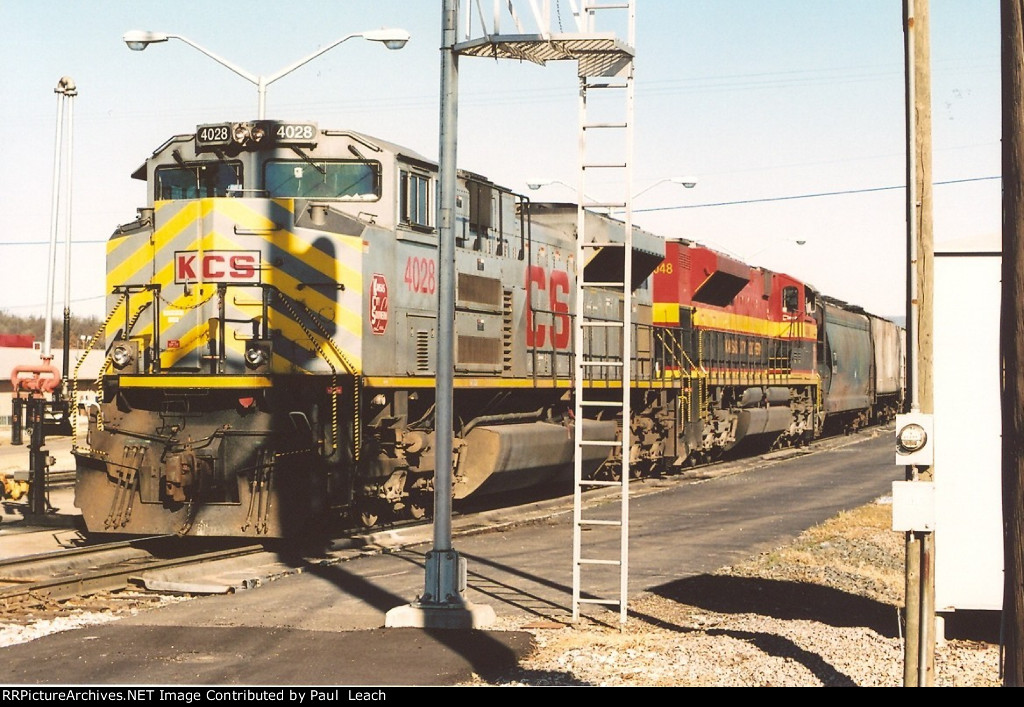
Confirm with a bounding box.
[999,0,1024,688]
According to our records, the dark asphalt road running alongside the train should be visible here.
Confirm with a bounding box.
[0,424,902,685]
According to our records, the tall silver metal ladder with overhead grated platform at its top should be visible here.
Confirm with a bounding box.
[456,0,636,623]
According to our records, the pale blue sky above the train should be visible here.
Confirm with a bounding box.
[0,0,1001,319]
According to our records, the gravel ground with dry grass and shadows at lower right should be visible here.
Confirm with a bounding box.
[460,499,1001,687]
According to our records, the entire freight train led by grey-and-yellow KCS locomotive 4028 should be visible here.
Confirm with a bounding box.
[73,120,903,538]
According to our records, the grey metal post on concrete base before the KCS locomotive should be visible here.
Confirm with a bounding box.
[385,0,495,628]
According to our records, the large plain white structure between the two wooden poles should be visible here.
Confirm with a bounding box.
[932,234,1002,612]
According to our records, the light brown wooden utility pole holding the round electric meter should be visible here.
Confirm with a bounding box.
[903,0,935,688]
